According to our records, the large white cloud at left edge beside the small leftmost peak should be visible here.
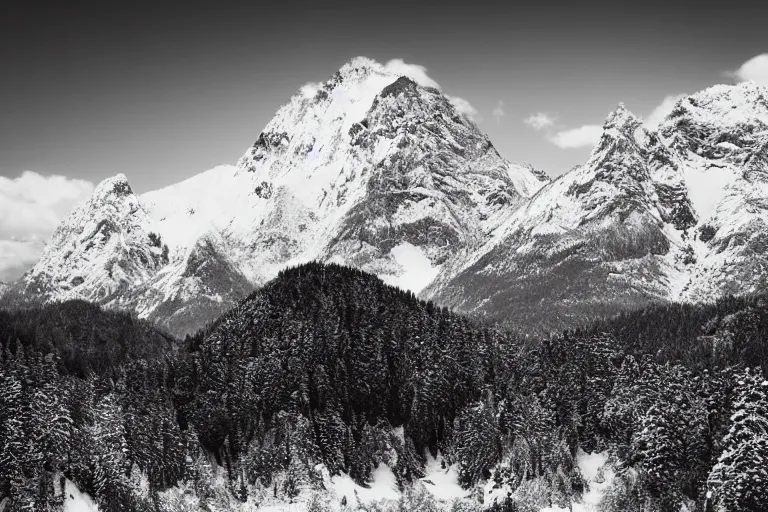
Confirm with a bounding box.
[0,171,93,279]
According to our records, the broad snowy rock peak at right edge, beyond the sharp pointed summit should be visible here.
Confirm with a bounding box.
[659,82,768,302]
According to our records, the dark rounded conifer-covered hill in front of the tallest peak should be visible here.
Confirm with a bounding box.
[199,263,514,462]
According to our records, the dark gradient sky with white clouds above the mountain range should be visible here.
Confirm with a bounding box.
[0,0,768,280]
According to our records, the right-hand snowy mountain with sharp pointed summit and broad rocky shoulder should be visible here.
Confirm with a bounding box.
[424,83,768,329]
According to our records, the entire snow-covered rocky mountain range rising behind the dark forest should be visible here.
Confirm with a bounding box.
[3,58,768,335]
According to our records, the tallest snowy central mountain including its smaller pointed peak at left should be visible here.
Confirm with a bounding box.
[7,58,547,334]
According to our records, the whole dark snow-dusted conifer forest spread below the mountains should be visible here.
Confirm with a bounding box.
[0,263,768,512]
